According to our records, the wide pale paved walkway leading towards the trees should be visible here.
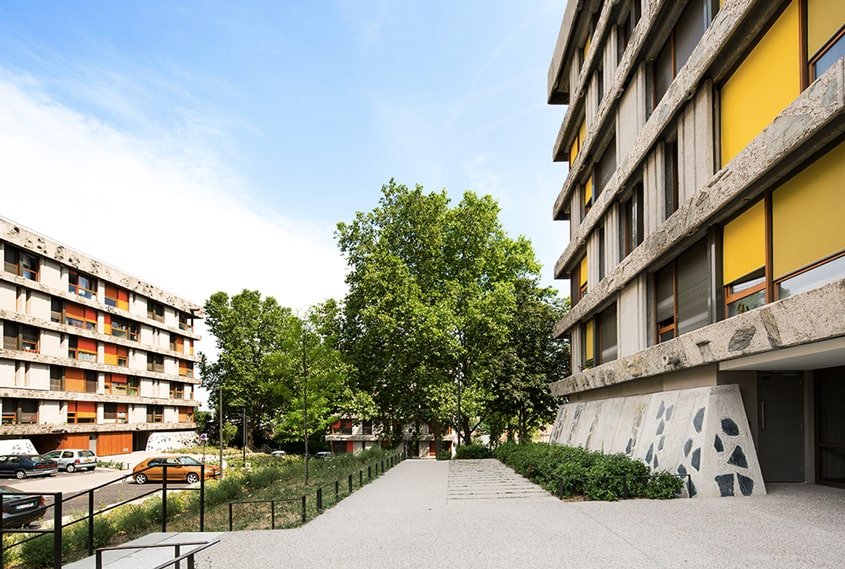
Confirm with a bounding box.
[191,460,845,569]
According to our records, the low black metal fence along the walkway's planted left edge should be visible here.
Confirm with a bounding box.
[228,452,406,531]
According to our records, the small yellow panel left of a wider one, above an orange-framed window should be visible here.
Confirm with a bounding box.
[722,200,766,284]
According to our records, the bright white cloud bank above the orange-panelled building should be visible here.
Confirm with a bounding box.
[0,74,345,349]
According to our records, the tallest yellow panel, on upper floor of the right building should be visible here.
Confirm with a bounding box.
[721,0,801,166]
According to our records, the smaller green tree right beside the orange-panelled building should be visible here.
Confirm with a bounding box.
[200,290,298,444]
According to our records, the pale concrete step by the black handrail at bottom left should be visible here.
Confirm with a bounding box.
[63,532,221,569]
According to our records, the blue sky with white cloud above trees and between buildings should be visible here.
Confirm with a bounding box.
[0,0,568,374]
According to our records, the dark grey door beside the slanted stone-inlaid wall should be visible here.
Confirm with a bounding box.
[757,372,804,482]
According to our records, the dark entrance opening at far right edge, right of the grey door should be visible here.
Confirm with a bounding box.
[813,367,845,487]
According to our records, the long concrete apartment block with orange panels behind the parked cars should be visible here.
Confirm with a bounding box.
[0,218,201,456]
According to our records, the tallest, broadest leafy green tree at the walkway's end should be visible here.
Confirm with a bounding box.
[337,180,539,441]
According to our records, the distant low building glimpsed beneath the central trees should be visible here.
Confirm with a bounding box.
[326,418,456,457]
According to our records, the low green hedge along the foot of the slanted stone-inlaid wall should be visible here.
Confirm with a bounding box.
[495,443,684,501]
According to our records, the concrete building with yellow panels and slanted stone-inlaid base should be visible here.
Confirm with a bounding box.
[548,0,845,496]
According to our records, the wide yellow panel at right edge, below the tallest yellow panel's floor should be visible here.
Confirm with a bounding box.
[772,143,845,279]
